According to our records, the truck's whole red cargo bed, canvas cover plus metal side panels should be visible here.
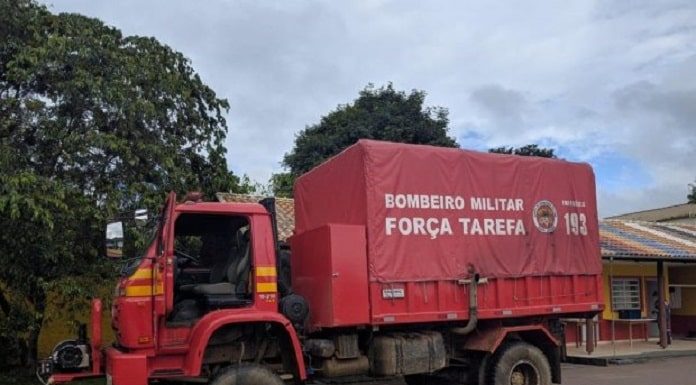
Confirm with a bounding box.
[291,140,603,328]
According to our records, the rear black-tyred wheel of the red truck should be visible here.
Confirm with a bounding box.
[487,342,551,385]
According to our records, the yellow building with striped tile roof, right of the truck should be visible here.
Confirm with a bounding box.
[566,216,696,343]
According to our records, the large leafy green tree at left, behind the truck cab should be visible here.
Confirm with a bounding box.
[0,0,239,363]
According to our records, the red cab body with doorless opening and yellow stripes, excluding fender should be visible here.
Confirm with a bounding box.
[113,192,278,332]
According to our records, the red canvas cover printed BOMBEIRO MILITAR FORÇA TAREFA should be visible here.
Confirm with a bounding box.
[294,140,601,282]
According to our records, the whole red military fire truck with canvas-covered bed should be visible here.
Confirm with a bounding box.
[40,140,603,385]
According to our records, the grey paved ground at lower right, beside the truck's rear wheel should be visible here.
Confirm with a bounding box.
[342,357,696,385]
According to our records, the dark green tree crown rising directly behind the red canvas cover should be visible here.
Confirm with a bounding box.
[271,83,457,196]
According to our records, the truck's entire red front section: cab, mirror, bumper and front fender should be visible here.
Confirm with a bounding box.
[43,193,304,385]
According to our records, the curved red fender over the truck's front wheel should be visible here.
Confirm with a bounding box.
[185,308,307,381]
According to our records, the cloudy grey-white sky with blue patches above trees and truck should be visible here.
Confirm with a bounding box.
[48,0,696,216]
